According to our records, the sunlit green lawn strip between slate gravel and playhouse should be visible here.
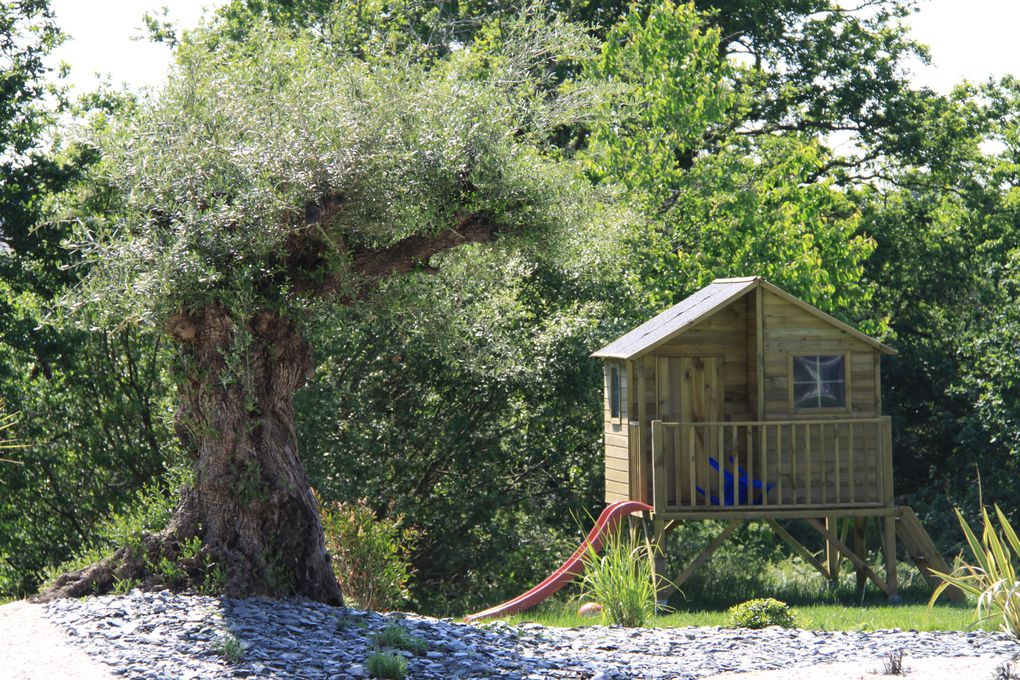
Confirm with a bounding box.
[504,603,974,631]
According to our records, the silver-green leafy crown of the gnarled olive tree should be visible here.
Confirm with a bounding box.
[64,17,593,324]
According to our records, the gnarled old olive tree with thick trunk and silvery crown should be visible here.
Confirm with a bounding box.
[48,24,594,603]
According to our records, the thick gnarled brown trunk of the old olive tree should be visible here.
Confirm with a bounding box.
[168,306,341,604]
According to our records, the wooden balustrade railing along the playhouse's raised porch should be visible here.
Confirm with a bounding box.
[648,417,893,513]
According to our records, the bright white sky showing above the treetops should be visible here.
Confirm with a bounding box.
[51,0,1020,92]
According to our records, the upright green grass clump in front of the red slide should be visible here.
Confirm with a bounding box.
[580,529,657,626]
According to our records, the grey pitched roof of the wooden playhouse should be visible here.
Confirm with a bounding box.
[592,276,896,360]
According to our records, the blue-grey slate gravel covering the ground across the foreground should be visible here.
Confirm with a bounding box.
[0,591,1020,680]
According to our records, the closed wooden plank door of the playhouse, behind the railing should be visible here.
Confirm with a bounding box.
[657,357,723,505]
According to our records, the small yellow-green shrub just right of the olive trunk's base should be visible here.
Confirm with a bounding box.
[322,500,419,611]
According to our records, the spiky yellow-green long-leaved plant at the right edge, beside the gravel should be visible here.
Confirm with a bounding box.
[928,506,1020,637]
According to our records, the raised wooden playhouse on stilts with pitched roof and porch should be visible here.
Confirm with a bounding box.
[593,277,959,598]
